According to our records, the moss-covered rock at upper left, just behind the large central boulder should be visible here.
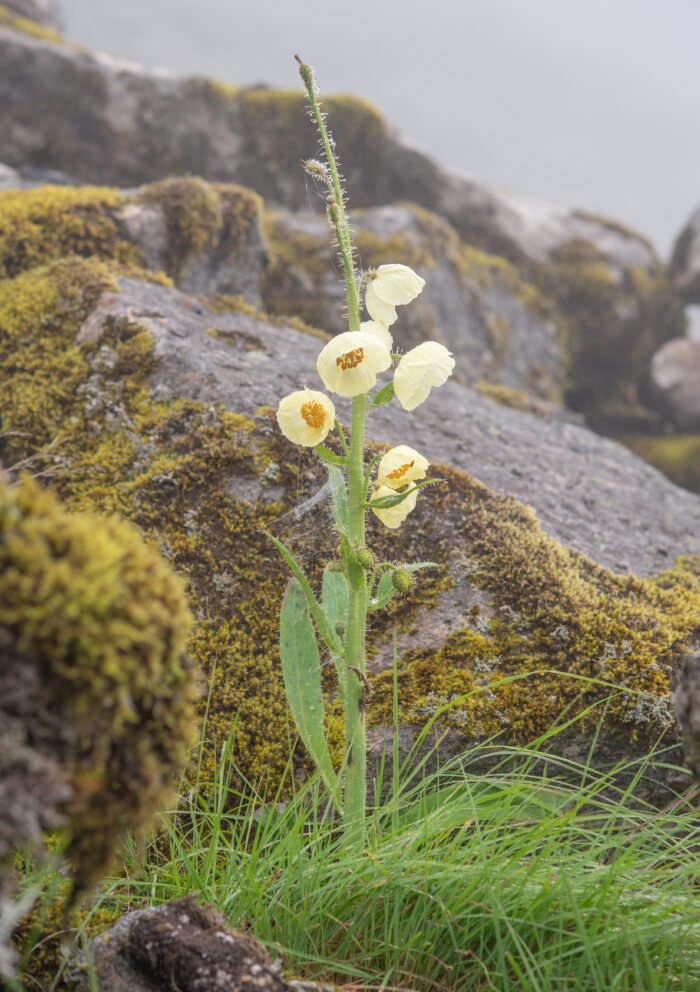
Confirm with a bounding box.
[0,177,267,306]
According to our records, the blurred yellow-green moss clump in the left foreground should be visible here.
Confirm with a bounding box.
[0,468,194,891]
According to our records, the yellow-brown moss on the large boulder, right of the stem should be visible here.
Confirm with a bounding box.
[369,466,700,743]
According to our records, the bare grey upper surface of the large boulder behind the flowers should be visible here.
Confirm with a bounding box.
[78,279,700,575]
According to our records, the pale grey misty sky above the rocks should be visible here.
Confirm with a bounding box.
[60,0,700,254]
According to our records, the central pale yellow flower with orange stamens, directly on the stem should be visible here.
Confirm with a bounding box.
[316,331,391,396]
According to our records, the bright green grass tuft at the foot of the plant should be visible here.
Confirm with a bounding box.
[12,688,700,992]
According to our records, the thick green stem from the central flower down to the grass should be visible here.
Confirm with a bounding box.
[343,395,367,846]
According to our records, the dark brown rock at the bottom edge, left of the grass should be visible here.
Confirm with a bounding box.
[69,896,293,992]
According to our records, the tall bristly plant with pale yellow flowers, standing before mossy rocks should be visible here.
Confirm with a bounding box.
[270,56,454,843]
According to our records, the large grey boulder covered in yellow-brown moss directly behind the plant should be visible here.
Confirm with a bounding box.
[0,194,700,864]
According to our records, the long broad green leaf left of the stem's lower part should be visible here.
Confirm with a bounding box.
[280,579,339,805]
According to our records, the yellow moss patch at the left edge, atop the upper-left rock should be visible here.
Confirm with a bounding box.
[0,186,139,278]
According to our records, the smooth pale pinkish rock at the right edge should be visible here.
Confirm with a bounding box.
[650,338,700,431]
